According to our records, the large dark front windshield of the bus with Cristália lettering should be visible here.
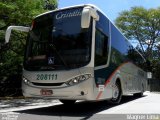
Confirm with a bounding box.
[24,8,92,70]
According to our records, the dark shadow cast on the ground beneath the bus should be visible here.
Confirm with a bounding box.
[19,96,145,120]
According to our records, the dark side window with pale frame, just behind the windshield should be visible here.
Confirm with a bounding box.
[95,29,108,66]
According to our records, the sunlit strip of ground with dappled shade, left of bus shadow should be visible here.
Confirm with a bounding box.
[0,97,60,113]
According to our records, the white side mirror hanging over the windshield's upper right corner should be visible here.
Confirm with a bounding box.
[81,7,99,28]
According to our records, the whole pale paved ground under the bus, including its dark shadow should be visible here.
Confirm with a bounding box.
[0,92,160,120]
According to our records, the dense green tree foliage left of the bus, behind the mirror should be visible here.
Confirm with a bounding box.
[0,0,57,96]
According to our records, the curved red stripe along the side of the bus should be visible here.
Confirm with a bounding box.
[96,62,129,100]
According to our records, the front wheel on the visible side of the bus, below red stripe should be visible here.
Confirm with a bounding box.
[109,80,122,104]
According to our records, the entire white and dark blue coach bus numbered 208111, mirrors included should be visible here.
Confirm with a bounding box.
[6,5,147,104]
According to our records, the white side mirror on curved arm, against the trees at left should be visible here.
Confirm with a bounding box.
[5,26,30,44]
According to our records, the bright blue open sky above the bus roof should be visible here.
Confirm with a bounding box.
[58,0,160,22]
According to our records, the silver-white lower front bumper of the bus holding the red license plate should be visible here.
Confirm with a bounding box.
[22,79,95,100]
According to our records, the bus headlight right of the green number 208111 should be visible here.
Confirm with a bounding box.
[66,74,91,85]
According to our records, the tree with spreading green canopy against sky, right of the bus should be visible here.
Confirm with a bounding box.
[115,7,160,59]
